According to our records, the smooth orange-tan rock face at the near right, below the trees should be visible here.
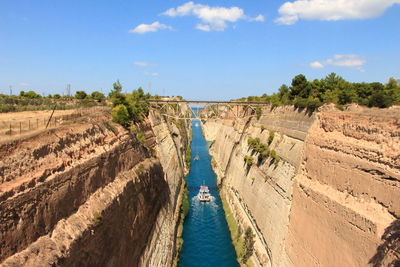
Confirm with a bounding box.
[287,110,400,266]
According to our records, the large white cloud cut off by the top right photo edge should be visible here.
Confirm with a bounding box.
[275,0,400,25]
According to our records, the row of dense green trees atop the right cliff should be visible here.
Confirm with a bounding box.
[242,73,400,108]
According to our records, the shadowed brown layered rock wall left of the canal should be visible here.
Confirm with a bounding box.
[0,107,190,266]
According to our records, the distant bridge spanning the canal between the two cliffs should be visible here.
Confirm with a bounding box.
[149,99,269,120]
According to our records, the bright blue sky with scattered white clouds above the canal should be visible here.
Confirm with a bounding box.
[0,0,400,100]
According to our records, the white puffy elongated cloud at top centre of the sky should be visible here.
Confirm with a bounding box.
[162,2,264,31]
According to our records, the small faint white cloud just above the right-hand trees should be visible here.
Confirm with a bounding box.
[309,54,366,71]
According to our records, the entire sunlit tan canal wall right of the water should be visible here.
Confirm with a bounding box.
[203,106,400,266]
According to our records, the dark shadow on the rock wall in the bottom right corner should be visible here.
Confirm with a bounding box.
[369,219,400,267]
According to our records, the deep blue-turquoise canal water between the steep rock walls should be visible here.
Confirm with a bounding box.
[180,120,239,267]
